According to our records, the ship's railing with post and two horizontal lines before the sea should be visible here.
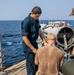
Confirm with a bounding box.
[0,34,24,71]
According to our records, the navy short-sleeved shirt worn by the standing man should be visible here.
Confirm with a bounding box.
[21,14,41,50]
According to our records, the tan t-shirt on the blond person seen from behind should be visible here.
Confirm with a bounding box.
[35,46,63,75]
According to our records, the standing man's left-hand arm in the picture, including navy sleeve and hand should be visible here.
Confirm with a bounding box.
[21,21,36,53]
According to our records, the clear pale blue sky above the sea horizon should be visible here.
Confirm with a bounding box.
[0,0,74,20]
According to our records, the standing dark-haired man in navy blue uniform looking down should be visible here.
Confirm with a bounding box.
[21,6,44,75]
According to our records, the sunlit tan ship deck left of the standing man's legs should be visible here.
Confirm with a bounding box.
[0,59,27,75]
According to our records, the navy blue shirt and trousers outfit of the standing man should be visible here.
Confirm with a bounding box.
[21,14,41,75]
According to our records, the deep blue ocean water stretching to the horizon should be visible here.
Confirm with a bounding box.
[0,20,74,67]
